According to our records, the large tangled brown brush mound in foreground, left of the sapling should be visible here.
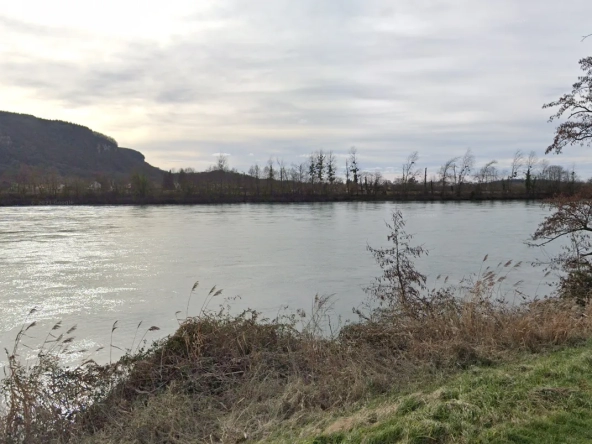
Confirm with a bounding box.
[70,298,397,442]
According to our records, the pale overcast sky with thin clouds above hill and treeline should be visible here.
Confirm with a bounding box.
[0,0,592,178]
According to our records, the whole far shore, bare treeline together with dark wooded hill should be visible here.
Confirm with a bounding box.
[0,112,586,205]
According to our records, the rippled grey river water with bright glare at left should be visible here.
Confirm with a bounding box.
[0,202,552,361]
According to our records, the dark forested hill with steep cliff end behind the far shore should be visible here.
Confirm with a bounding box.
[0,111,162,180]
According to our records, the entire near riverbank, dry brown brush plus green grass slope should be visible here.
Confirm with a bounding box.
[0,290,592,443]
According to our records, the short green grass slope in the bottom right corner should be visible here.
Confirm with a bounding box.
[272,342,592,444]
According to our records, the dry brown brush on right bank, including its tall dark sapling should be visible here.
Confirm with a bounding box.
[341,211,591,368]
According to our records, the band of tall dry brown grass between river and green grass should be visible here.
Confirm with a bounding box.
[0,280,592,443]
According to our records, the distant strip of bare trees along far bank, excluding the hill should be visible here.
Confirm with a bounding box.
[0,148,587,205]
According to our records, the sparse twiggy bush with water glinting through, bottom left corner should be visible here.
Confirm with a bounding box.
[0,309,122,443]
